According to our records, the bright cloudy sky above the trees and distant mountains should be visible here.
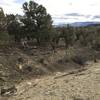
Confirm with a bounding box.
[0,0,100,24]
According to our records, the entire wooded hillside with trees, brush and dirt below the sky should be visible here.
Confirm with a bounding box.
[0,1,100,100]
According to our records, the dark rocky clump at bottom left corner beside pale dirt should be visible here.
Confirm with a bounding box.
[1,86,17,96]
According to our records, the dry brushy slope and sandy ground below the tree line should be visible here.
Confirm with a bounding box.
[0,46,100,100]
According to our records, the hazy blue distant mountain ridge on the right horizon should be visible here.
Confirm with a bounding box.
[55,22,100,27]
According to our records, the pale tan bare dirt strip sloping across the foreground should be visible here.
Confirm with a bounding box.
[0,61,100,100]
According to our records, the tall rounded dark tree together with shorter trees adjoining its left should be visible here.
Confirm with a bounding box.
[6,1,53,44]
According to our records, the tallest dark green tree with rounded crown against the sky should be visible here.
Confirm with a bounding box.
[21,1,52,44]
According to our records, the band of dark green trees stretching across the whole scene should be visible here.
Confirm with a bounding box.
[0,1,100,50]
